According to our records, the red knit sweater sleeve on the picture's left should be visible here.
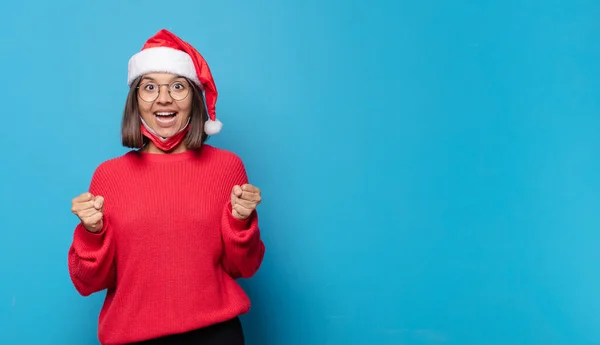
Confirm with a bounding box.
[68,165,116,296]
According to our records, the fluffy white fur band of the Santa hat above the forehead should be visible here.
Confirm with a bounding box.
[127,47,200,86]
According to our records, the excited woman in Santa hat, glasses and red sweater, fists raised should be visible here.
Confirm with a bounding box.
[68,30,265,345]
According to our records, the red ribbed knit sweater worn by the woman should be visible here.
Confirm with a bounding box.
[68,145,265,345]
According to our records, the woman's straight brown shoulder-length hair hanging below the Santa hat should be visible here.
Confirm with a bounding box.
[121,77,208,150]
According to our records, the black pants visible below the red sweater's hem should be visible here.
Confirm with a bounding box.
[134,317,244,345]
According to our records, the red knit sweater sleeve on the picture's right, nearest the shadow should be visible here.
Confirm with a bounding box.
[221,155,265,279]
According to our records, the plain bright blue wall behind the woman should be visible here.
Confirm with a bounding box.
[0,0,600,345]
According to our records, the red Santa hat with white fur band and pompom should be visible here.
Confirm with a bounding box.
[127,29,223,135]
